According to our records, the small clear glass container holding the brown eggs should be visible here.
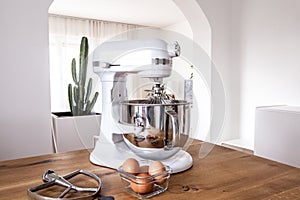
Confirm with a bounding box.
[118,166,172,199]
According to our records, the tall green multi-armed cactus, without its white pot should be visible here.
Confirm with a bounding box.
[68,37,98,116]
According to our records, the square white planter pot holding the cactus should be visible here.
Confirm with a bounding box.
[52,113,101,152]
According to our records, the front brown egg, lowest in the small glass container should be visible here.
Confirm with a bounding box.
[130,173,154,194]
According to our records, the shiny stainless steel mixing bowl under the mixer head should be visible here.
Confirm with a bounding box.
[120,99,191,160]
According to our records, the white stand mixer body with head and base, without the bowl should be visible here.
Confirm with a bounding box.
[90,39,193,173]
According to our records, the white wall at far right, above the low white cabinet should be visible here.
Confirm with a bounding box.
[234,0,300,148]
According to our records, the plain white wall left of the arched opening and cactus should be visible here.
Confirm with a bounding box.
[0,0,52,160]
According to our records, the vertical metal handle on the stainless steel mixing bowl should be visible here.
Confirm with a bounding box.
[164,110,179,150]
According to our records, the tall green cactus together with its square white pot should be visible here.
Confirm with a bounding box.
[52,37,100,152]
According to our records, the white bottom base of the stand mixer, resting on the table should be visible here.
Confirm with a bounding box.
[90,140,193,173]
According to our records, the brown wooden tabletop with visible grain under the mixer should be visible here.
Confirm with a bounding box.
[0,141,300,200]
